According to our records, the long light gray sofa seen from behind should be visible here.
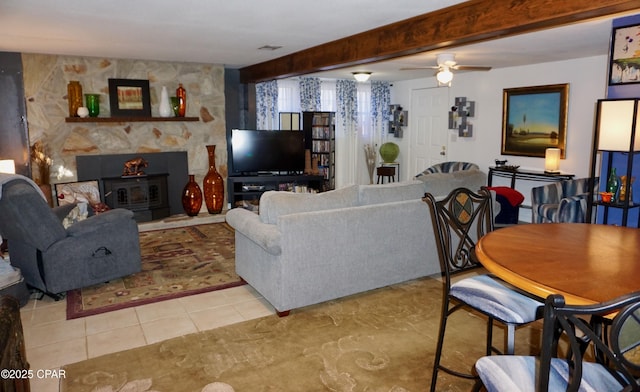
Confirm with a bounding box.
[226,170,486,315]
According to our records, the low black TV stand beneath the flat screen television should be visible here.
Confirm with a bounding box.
[227,173,325,208]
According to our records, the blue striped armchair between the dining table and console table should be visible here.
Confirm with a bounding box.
[531,178,598,223]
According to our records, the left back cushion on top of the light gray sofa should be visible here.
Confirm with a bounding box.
[260,185,358,224]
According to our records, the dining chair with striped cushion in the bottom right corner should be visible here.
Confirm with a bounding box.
[475,292,640,392]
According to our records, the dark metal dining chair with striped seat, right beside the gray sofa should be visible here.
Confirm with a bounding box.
[423,187,544,391]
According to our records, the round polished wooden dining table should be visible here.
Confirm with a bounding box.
[475,223,640,305]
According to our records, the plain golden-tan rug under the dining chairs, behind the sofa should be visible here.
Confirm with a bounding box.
[60,278,539,392]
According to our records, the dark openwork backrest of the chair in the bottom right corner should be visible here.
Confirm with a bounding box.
[536,292,640,391]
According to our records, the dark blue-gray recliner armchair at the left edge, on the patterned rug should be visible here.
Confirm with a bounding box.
[0,174,141,299]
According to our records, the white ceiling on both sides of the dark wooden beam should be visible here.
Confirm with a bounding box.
[0,0,636,81]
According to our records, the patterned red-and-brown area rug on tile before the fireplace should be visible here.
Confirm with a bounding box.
[67,223,245,319]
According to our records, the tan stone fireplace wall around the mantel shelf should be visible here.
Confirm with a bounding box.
[22,54,227,211]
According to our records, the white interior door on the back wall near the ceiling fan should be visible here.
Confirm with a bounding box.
[409,87,449,175]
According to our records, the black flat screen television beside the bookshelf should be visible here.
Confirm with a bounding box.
[231,129,304,175]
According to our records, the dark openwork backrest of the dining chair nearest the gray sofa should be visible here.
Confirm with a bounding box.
[423,187,493,289]
